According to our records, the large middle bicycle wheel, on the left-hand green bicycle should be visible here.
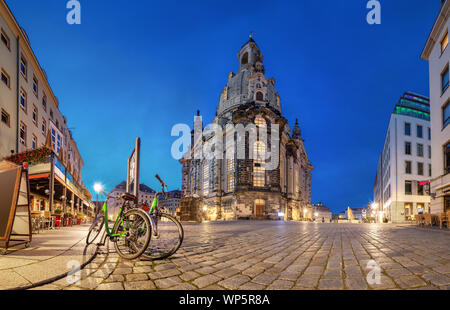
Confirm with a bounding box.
[112,209,151,259]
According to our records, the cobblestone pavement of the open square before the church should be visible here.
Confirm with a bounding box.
[31,221,450,290]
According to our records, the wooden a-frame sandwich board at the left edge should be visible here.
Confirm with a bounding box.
[0,161,32,254]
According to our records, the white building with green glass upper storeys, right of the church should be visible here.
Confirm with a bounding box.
[374,92,432,223]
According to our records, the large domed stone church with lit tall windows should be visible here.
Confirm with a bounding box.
[180,37,313,220]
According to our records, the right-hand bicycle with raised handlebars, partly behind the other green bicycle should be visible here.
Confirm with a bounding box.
[141,175,184,260]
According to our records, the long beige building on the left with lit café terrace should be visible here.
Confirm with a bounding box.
[0,0,94,215]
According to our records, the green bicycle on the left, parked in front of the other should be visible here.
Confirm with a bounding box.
[86,193,152,259]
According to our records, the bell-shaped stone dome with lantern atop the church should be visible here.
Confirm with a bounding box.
[216,35,281,117]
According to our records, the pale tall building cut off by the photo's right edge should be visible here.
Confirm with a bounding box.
[422,1,450,214]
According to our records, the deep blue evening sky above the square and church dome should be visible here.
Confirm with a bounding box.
[7,0,440,213]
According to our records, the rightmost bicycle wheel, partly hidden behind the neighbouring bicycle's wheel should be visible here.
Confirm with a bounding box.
[142,213,184,260]
